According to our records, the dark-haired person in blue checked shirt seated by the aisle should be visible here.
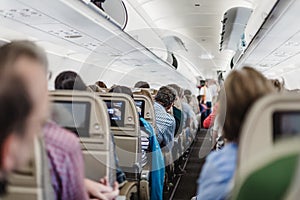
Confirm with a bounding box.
[154,86,176,150]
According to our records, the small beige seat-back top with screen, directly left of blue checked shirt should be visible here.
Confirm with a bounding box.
[134,94,156,127]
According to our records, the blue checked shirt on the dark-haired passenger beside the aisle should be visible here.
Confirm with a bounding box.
[154,102,176,150]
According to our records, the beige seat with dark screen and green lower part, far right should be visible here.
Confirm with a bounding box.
[233,94,300,199]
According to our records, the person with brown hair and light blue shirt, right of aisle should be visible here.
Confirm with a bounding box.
[197,67,274,200]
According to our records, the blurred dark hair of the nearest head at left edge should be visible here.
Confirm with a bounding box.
[0,75,33,158]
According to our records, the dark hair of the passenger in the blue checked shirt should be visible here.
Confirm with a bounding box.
[155,86,176,108]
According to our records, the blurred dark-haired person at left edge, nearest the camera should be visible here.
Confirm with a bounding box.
[0,75,33,196]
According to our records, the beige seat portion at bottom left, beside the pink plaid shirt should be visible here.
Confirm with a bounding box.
[1,137,55,200]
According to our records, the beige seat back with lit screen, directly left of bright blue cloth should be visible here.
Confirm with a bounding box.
[98,93,142,180]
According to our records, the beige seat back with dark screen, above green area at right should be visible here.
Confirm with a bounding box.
[238,93,300,169]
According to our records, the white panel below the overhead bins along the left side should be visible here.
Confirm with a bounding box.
[0,0,197,88]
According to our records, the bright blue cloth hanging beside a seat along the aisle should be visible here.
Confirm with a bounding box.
[140,117,165,200]
